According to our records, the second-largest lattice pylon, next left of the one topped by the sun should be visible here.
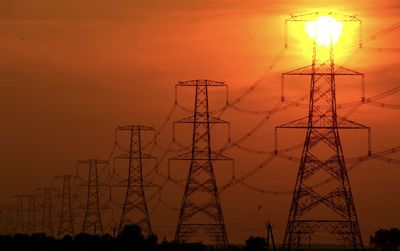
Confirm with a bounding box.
[171,80,232,245]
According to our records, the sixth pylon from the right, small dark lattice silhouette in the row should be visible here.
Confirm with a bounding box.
[37,187,55,236]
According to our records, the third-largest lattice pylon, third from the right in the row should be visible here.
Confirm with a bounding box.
[116,125,158,234]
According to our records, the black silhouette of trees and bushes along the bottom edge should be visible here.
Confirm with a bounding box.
[0,225,400,251]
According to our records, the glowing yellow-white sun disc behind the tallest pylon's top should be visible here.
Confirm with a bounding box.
[305,16,342,46]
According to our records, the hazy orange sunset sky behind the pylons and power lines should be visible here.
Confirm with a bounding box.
[0,0,400,243]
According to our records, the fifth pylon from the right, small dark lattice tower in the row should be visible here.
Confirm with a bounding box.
[55,175,76,237]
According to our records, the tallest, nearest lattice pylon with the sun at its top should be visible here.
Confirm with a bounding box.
[277,13,369,250]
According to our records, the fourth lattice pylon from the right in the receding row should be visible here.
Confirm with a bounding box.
[78,159,108,234]
